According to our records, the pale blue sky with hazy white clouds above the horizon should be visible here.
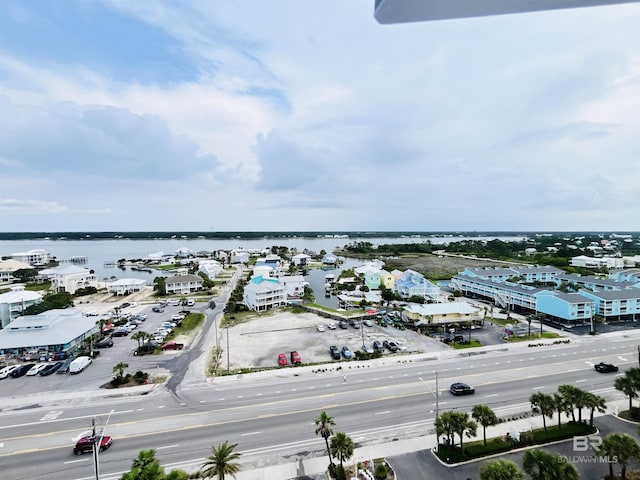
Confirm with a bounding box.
[0,0,640,232]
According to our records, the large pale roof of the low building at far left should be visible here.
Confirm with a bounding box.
[0,308,98,350]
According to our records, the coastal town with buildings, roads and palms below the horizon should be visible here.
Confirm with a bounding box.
[0,232,640,479]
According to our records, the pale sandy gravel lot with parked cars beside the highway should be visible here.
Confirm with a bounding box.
[224,312,449,369]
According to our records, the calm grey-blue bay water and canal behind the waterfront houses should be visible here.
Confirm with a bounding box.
[0,237,522,307]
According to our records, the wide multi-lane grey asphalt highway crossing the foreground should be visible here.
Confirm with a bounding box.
[0,331,640,480]
